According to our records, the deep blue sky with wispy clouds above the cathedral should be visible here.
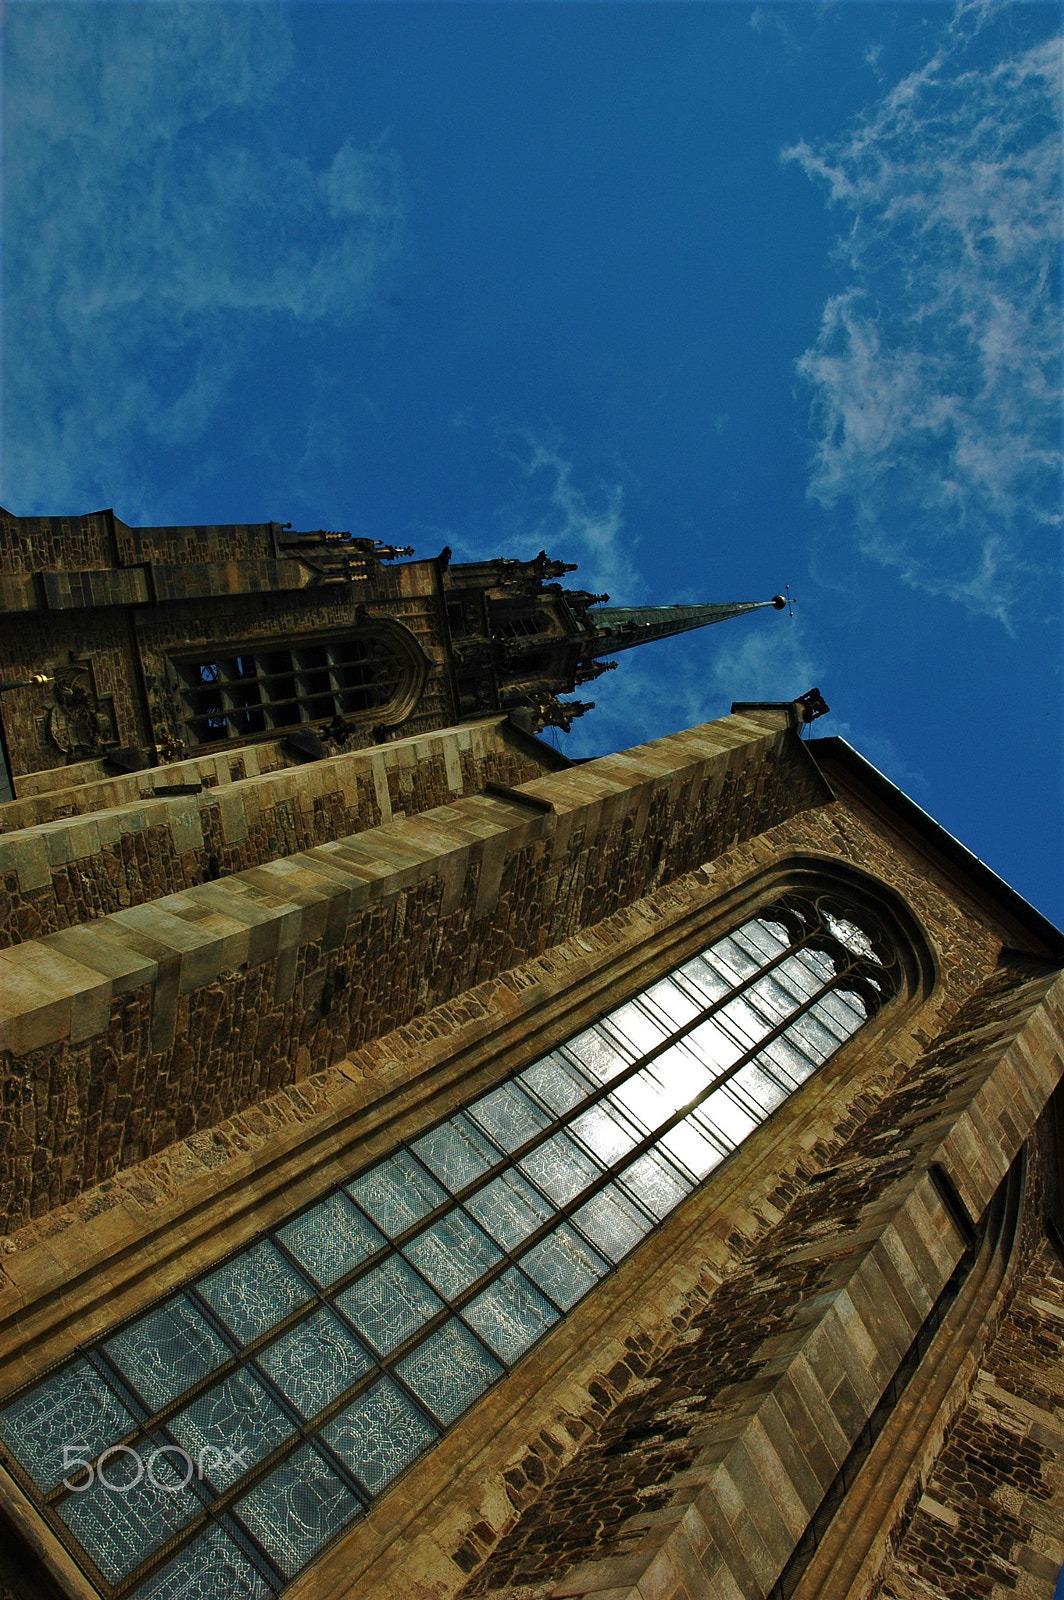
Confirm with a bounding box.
[0,0,1064,923]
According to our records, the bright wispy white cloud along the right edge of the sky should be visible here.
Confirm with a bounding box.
[784,3,1061,626]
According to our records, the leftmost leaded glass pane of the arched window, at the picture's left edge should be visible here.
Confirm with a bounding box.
[0,1360,136,1490]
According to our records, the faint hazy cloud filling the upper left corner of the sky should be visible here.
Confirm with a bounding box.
[3,5,405,517]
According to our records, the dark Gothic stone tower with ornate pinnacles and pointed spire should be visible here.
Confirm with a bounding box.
[0,510,782,798]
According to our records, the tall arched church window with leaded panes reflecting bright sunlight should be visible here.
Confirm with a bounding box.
[0,894,901,1600]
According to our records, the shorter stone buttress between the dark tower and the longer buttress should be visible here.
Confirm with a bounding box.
[0,718,544,949]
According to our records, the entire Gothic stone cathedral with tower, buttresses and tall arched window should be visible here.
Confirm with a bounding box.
[0,512,1064,1600]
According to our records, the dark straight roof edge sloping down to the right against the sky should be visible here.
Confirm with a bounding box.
[805,734,1064,963]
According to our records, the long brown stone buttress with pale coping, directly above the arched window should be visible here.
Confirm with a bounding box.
[0,717,824,1221]
